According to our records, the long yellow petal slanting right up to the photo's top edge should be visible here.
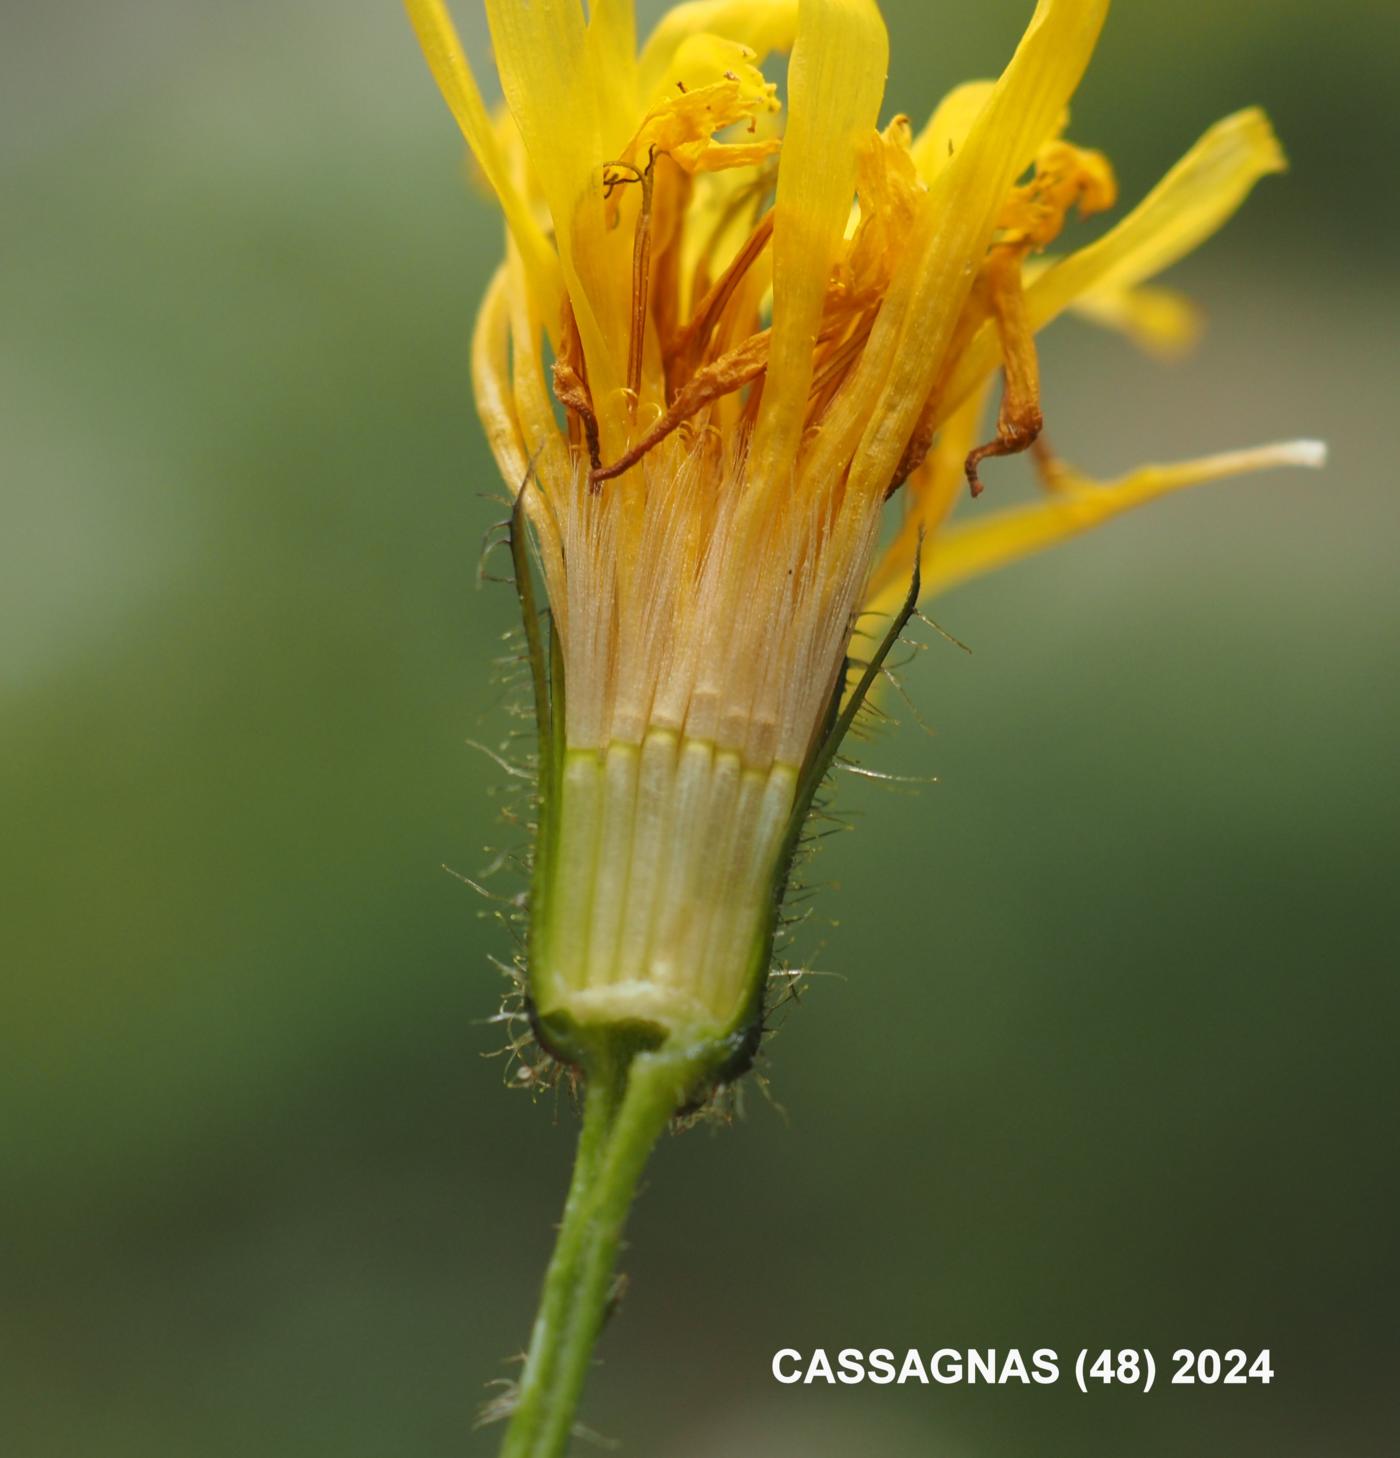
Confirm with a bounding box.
[808,0,1108,499]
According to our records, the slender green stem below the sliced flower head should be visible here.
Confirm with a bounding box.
[500,1048,713,1458]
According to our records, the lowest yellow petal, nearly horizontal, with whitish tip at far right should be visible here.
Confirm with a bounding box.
[915,440,1327,611]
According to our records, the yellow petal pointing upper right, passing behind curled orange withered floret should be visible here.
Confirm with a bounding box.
[944,108,1286,413]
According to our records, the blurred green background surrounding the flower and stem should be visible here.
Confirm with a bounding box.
[0,0,1400,1458]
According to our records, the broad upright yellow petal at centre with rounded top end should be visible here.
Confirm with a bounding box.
[750,0,890,488]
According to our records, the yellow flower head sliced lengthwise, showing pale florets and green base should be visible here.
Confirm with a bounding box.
[407,0,1314,1084]
